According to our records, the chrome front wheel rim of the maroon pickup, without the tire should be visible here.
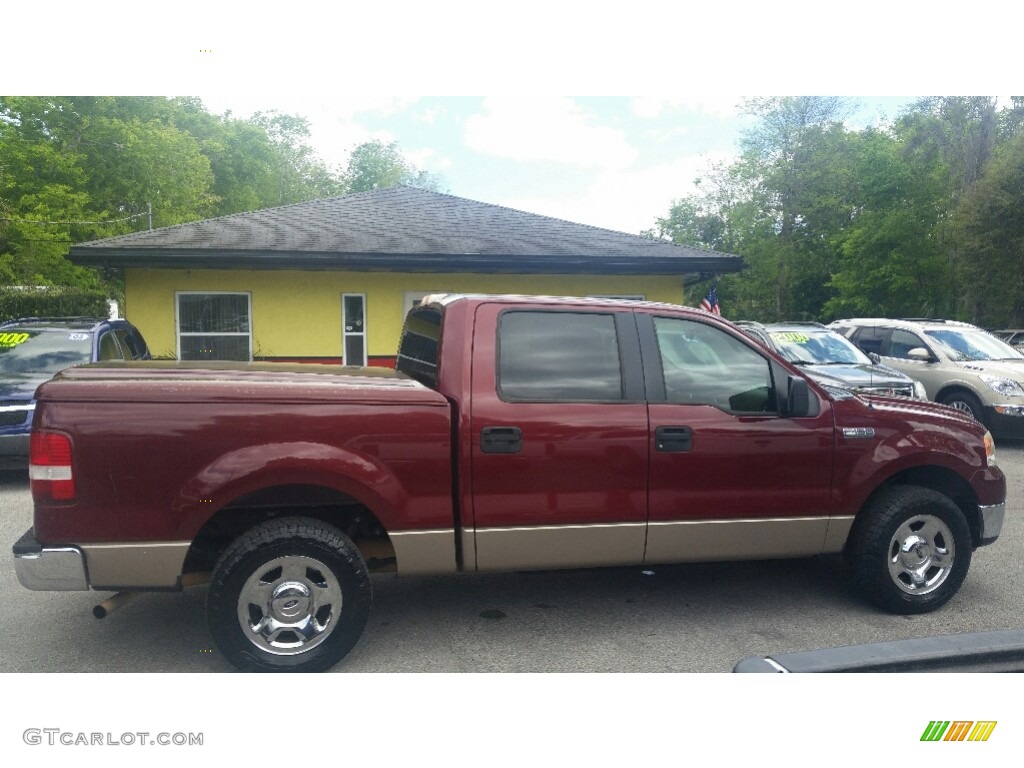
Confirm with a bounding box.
[889,515,956,595]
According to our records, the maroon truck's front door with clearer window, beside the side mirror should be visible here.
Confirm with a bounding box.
[638,314,834,563]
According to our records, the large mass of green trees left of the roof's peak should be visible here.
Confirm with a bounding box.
[0,96,385,293]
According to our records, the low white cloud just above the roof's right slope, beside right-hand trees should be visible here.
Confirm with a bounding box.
[494,153,732,234]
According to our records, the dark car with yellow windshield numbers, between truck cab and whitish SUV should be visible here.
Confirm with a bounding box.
[736,321,928,399]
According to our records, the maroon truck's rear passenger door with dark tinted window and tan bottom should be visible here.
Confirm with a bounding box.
[471,303,649,570]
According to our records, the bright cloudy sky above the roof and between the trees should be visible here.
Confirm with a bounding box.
[199,93,909,233]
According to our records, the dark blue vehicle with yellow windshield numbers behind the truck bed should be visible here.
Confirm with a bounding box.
[0,317,150,468]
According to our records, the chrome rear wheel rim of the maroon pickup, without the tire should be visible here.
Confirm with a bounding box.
[238,555,342,655]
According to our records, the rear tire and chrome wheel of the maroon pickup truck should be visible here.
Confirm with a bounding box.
[206,517,372,672]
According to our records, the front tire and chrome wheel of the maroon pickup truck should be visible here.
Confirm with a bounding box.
[847,485,972,614]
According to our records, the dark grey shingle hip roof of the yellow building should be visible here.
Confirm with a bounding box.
[70,186,743,274]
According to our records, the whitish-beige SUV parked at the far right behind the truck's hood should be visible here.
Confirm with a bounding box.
[828,317,1024,437]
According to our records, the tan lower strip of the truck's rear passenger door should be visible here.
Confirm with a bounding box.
[467,522,647,570]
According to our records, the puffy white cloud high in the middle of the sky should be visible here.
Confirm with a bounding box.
[465,96,639,168]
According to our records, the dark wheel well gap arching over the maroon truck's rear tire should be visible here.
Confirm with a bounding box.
[183,485,396,573]
